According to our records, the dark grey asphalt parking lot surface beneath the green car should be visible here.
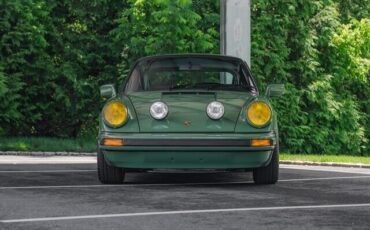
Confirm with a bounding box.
[0,157,370,230]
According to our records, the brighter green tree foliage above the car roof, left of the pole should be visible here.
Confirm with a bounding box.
[115,0,214,66]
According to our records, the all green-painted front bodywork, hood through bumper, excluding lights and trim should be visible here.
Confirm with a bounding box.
[98,92,278,169]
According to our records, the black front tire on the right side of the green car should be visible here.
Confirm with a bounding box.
[253,147,279,184]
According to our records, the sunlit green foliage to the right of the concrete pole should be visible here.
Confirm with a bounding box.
[252,0,370,153]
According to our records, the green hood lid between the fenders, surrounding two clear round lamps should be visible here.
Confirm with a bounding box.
[127,91,252,133]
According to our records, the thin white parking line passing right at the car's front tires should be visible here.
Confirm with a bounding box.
[0,176,370,190]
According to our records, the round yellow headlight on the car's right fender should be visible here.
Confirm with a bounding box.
[247,101,272,127]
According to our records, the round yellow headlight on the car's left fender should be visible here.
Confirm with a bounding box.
[103,101,128,127]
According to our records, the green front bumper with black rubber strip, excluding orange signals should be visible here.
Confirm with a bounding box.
[99,132,276,169]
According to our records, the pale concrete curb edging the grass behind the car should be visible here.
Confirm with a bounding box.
[0,151,370,168]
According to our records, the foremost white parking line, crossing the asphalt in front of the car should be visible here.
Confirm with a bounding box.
[0,203,370,223]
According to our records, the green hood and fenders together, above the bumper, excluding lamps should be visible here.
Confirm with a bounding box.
[99,91,277,133]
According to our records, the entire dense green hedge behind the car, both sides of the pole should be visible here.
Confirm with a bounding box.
[0,0,370,155]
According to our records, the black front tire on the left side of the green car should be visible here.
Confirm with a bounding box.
[98,150,125,184]
